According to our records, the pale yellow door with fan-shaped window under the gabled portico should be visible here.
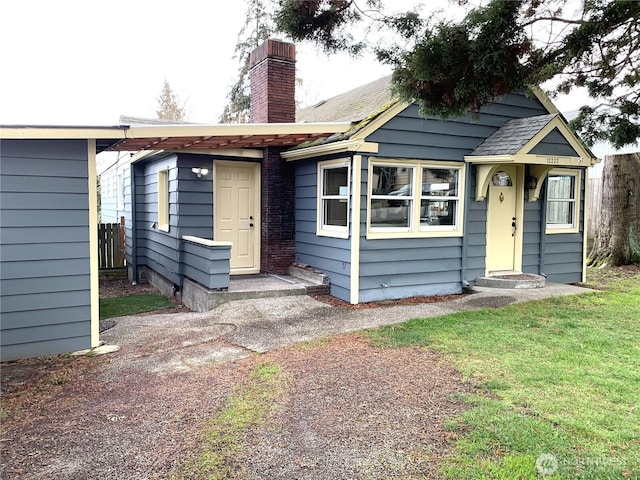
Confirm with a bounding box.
[486,165,522,275]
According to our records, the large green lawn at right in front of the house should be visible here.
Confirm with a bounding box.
[371,276,640,480]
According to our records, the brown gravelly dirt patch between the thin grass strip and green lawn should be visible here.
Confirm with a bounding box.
[237,335,470,479]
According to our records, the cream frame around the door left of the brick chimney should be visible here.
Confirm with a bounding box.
[213,160,261,275]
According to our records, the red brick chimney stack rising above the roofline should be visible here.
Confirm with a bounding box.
[249,39,296,123]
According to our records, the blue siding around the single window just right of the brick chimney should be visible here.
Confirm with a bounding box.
[296,161,353,301]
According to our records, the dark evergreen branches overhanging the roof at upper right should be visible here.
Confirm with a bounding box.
[275,0,640,147]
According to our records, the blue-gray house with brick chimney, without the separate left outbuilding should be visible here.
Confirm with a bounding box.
[103,40,597,303]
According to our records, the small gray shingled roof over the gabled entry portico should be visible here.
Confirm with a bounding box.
[471,113,557,156]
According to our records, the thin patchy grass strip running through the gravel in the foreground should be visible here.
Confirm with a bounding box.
[180,362,287,480]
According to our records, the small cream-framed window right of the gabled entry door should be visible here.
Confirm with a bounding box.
[547,170,580,233]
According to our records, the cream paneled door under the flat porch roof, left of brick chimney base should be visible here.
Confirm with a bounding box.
[213,161,260,274]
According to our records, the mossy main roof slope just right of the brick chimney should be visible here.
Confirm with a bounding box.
[296,75,394,123]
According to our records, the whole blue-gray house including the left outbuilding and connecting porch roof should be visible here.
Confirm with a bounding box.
[0,40,597,361]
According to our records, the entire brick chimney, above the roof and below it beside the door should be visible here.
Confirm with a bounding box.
[249,40,296,274]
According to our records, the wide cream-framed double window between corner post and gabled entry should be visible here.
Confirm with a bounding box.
[367,160,464,238]
